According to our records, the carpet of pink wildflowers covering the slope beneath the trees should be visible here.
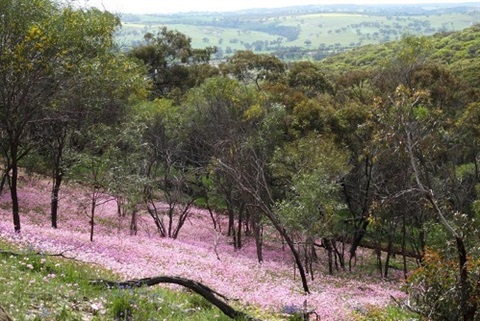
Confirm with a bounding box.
[0,177,405,321]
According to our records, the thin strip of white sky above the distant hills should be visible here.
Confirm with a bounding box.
[81,0,480,13]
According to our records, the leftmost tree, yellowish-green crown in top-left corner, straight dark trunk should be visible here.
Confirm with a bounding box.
[0,0,131,232]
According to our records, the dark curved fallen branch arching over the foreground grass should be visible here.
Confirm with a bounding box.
[90,276,260,321]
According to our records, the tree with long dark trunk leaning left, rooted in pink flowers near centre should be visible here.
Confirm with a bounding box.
[184,77,309,292]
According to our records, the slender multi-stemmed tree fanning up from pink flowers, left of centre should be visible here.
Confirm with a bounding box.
[140,99,203,238]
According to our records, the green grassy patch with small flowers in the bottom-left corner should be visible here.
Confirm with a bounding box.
[0,241,248,321]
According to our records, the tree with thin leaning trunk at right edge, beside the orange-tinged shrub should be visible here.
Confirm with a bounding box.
[377,86,478,321]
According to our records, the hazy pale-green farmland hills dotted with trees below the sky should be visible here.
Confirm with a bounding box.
[118,2,480,60]
